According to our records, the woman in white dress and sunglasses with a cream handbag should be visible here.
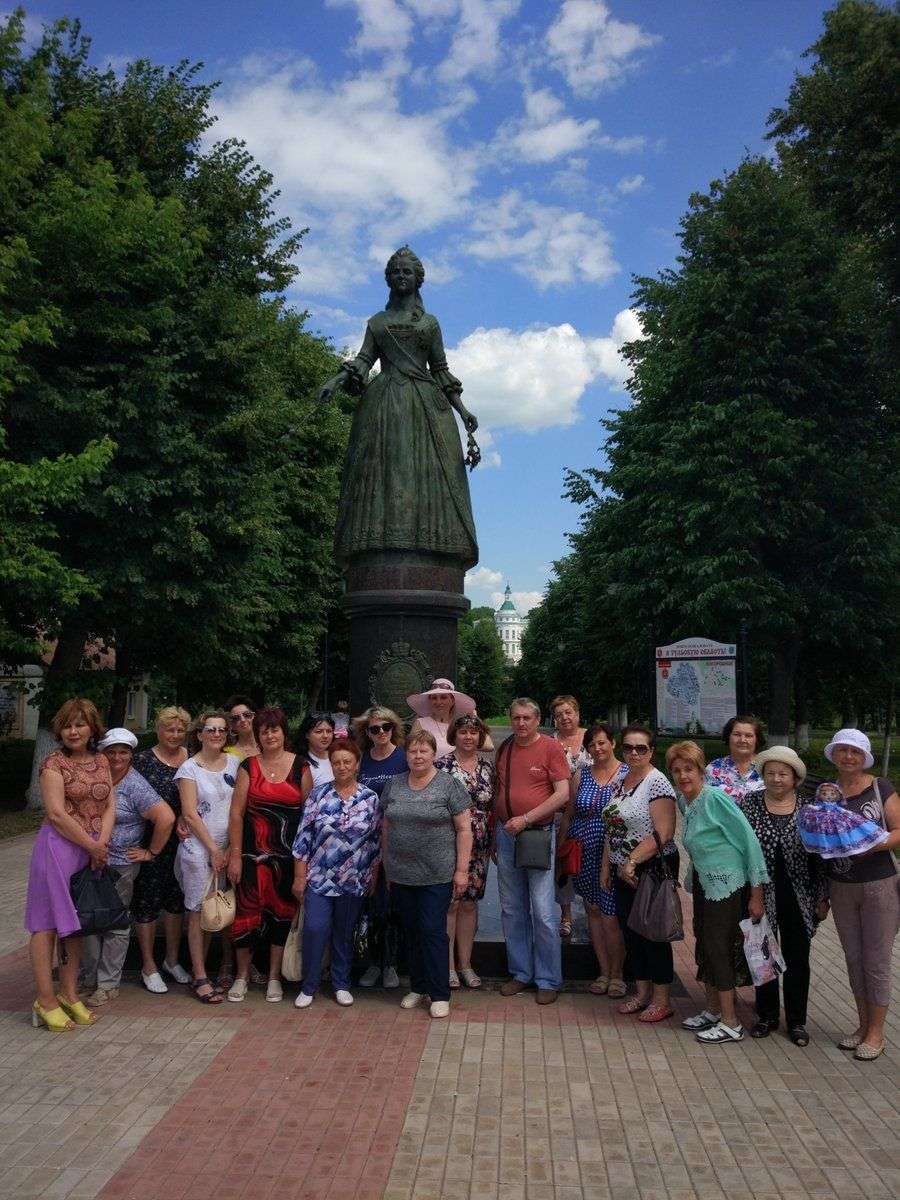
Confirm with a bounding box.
[175,709,240,1004]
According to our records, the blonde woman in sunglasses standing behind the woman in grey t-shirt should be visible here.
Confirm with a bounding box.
[353,706,409,988]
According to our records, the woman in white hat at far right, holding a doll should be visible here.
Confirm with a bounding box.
[824,730,900,1062]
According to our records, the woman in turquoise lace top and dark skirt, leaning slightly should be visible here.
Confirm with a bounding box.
[666,742,769,1044]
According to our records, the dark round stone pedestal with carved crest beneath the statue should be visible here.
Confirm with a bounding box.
[343,551,469,716]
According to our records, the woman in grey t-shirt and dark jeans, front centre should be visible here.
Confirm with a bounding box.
[382,730,472,1016]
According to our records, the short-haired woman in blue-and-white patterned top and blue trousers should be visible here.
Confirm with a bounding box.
[293,738,382,1008]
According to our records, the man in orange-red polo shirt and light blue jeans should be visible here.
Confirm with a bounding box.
[494,696,570,1004]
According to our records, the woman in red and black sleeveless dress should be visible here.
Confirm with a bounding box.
[228,708,312,1002]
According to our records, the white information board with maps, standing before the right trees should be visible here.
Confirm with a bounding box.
[656,637,738,736]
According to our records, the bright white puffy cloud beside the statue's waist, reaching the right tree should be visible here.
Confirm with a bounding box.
[449,308,641,432]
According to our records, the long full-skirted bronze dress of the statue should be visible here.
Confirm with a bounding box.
[335,310,478,569]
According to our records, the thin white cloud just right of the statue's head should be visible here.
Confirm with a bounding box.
[463,191,619,288]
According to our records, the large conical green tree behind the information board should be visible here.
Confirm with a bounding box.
[570,160,896,738]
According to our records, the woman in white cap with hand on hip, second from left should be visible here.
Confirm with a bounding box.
[82,728,175,1008]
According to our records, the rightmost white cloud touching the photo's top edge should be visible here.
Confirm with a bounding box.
[546,0,660,95]
